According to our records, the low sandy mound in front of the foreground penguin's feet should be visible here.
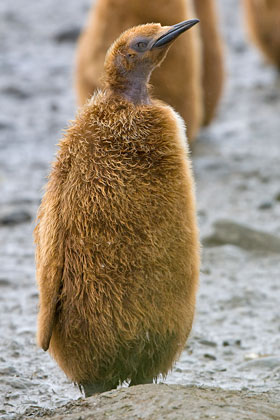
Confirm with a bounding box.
[15,384,280,420]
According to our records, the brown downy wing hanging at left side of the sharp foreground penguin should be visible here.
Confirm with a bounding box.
[34,176,65,351]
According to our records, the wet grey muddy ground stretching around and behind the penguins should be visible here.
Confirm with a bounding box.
[0,0,280,420]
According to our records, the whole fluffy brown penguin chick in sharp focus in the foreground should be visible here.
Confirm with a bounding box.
[35,19,199,396]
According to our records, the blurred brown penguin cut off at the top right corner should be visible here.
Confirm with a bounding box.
[243,0,280,70]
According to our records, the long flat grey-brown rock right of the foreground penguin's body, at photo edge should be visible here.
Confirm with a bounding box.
[202,220,280,253]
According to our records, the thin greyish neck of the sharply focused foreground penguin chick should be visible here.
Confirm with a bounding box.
[105,70,151,105]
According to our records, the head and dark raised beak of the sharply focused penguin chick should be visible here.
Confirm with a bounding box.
[104,19,199,90]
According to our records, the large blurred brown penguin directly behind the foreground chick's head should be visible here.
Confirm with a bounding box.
[76,0,203,141]
